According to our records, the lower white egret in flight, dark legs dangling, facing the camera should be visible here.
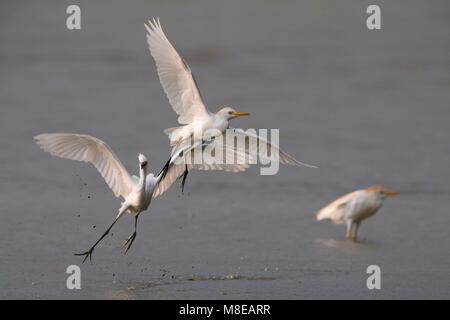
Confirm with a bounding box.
[34,133,248,263]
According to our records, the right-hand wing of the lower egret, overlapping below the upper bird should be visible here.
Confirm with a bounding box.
[153,140,252,198]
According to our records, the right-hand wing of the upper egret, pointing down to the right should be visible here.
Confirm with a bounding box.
[225,128,317,168]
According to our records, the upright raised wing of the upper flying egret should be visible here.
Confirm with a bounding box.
[145,19,208,124]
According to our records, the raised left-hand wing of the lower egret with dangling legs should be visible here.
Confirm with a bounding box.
[34,133,133,198]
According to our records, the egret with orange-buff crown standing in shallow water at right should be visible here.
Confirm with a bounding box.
[316,186,398,241]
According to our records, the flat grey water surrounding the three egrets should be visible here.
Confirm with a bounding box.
[0,1,450,299]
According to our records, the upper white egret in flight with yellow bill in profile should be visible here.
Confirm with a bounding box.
[145,19,315,182]
